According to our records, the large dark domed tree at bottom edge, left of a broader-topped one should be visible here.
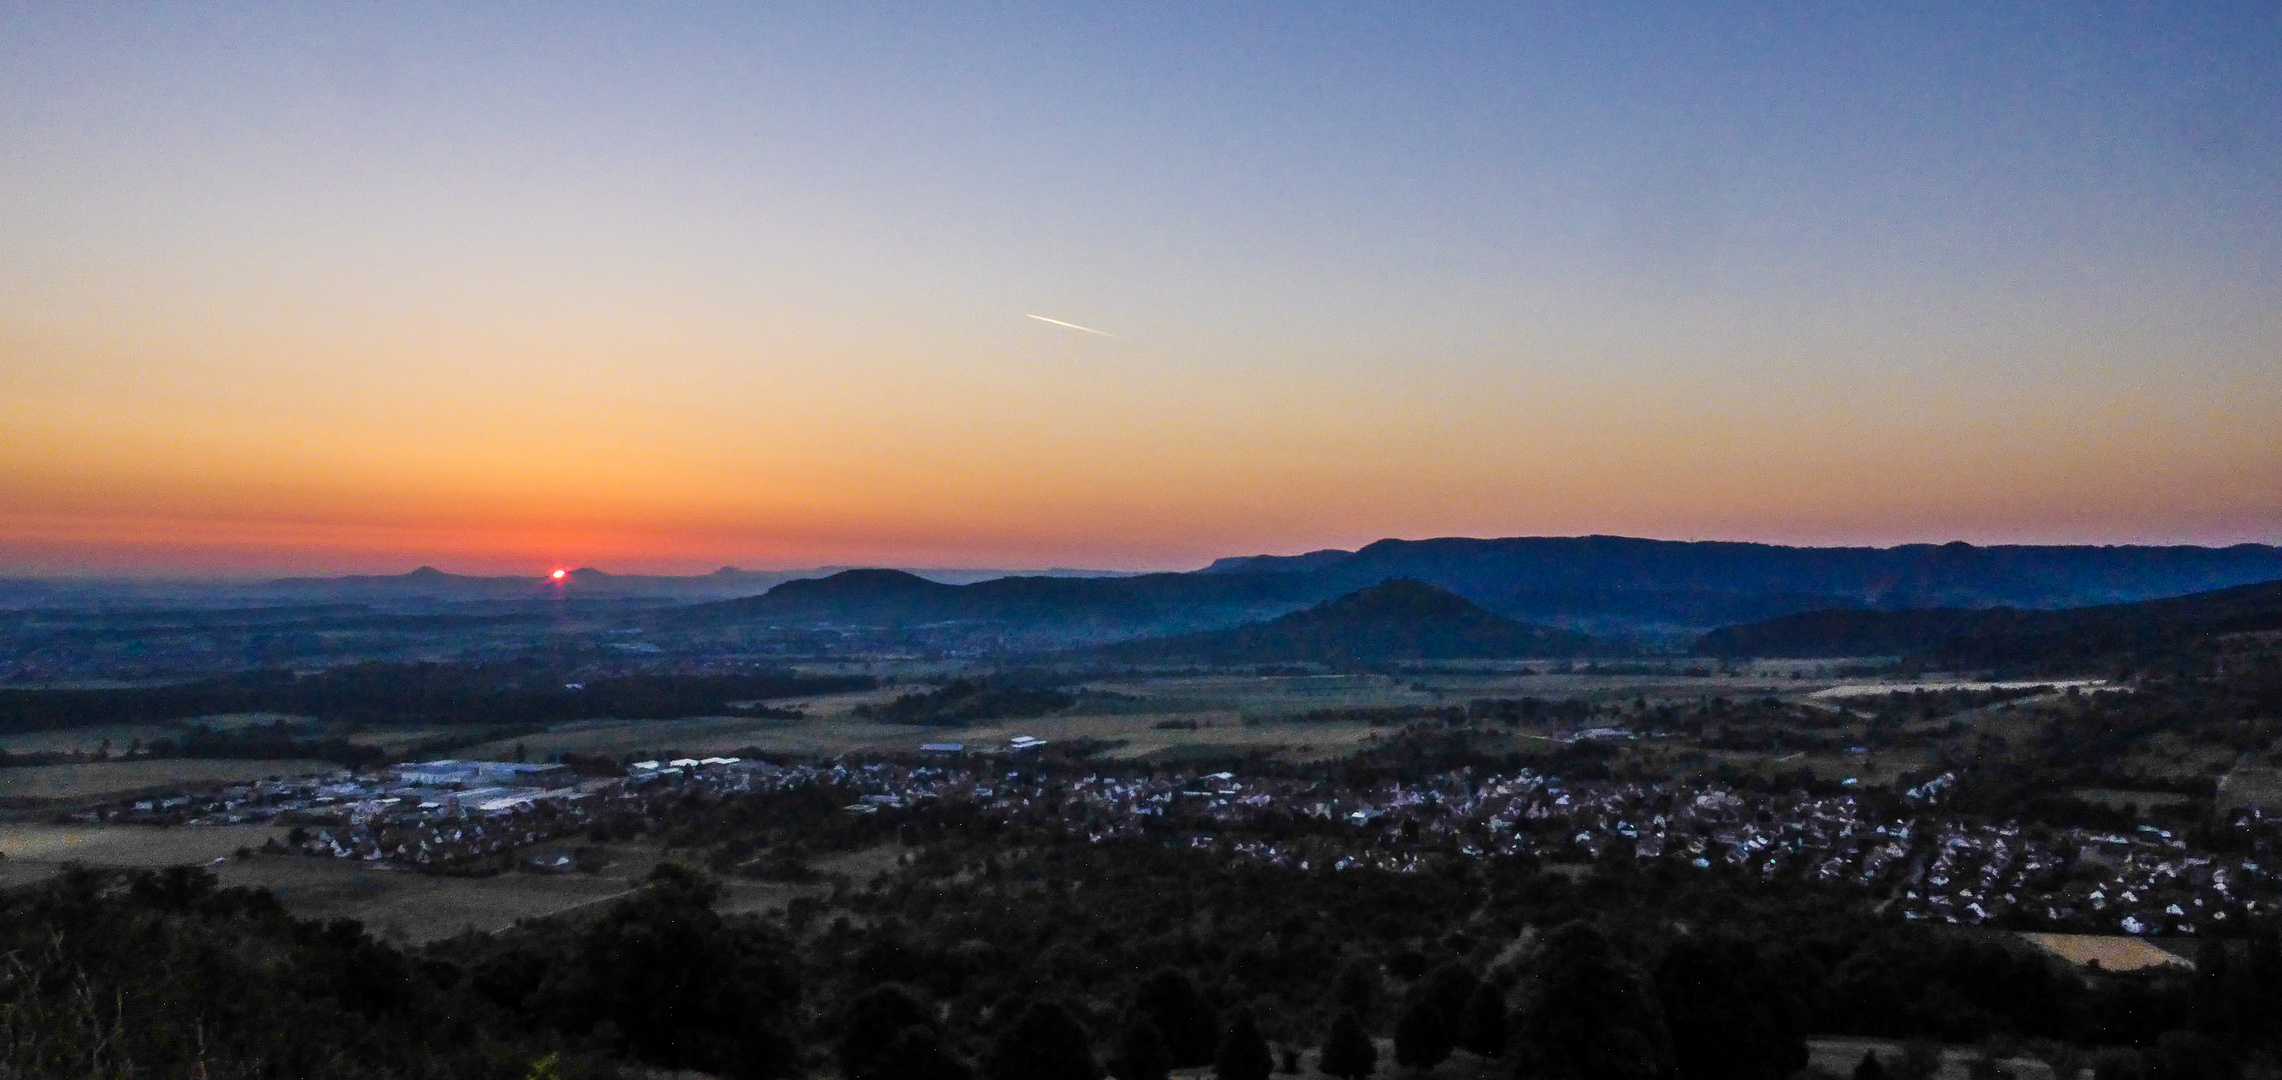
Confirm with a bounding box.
[1511,922,1673,1080]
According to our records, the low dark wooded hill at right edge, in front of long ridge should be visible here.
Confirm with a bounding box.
[1696,580,2282,664]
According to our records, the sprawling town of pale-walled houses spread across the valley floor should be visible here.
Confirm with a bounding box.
[84,740,2282,934]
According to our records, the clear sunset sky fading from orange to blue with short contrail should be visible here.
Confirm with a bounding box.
[0,0,2282,575]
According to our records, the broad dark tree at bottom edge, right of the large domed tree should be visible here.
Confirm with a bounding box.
[1657,938,1807,1080]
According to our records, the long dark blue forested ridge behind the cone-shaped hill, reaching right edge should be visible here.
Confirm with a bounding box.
[659,537,2282,639]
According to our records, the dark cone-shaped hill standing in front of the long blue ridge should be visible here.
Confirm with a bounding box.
[1098,580,1595,667]
